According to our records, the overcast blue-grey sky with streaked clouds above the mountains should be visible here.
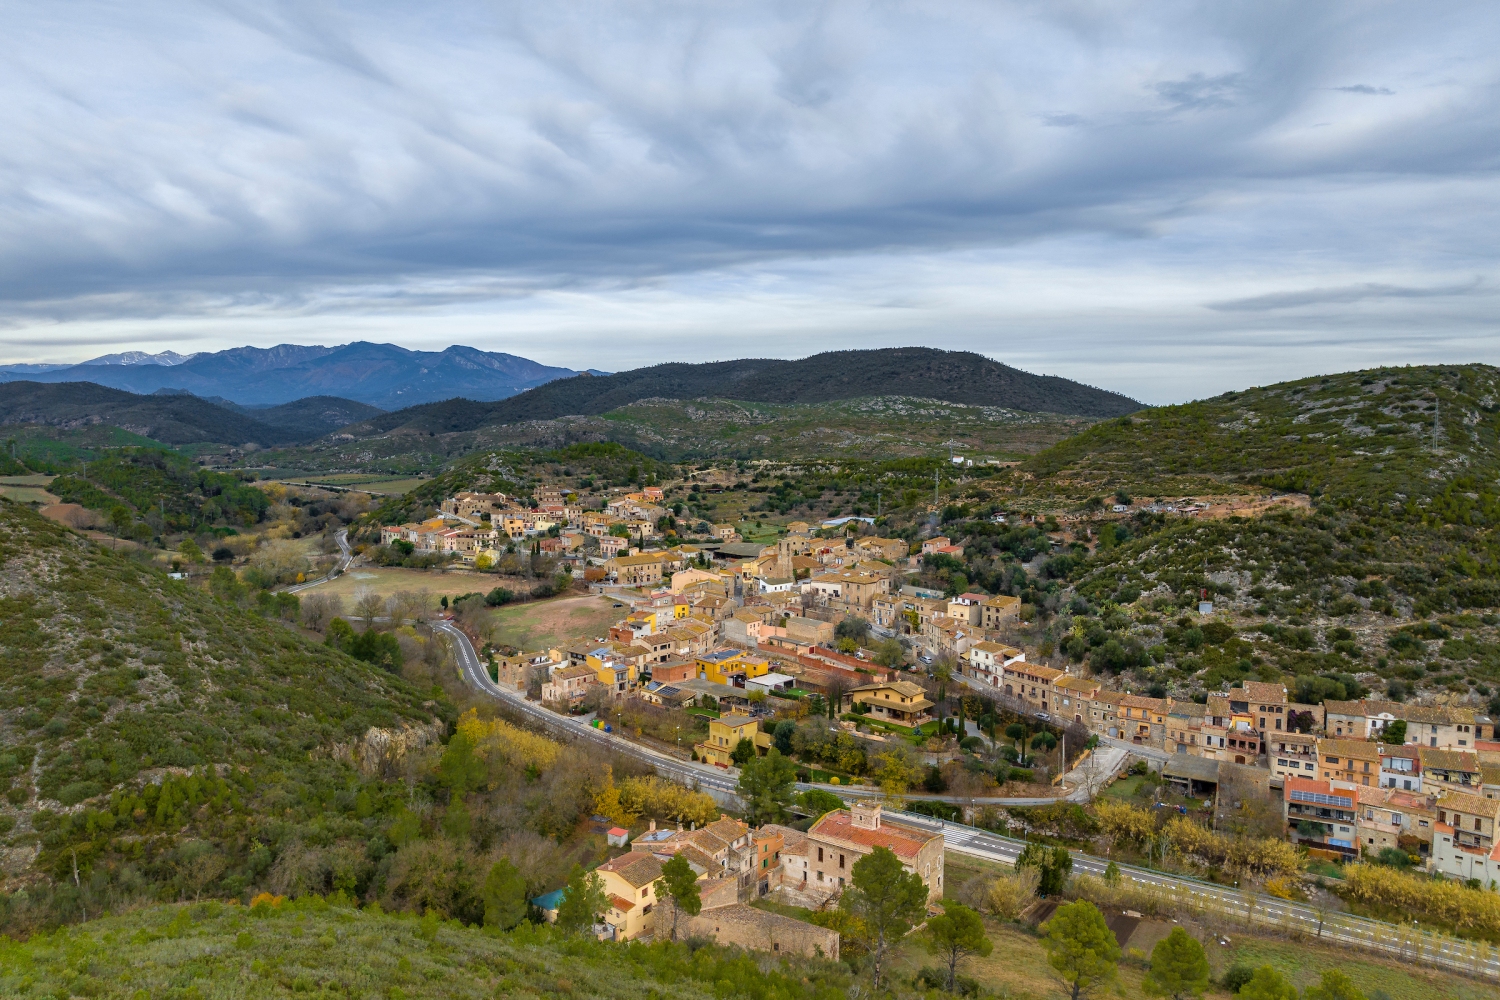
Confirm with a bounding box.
[0,0,1500,403]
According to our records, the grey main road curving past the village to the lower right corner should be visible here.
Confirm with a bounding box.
[432,619,1500,979]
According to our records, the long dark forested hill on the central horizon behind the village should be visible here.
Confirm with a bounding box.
[348,348,1140,435]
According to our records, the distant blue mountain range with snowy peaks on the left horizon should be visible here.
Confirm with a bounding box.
[0,342,578,409]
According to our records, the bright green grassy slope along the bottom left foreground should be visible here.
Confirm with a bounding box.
[0,898,849,1000]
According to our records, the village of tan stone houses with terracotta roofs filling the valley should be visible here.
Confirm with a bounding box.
[383,487,1500,955]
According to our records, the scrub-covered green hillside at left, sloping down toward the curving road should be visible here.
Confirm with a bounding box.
[0,501,444,905]
